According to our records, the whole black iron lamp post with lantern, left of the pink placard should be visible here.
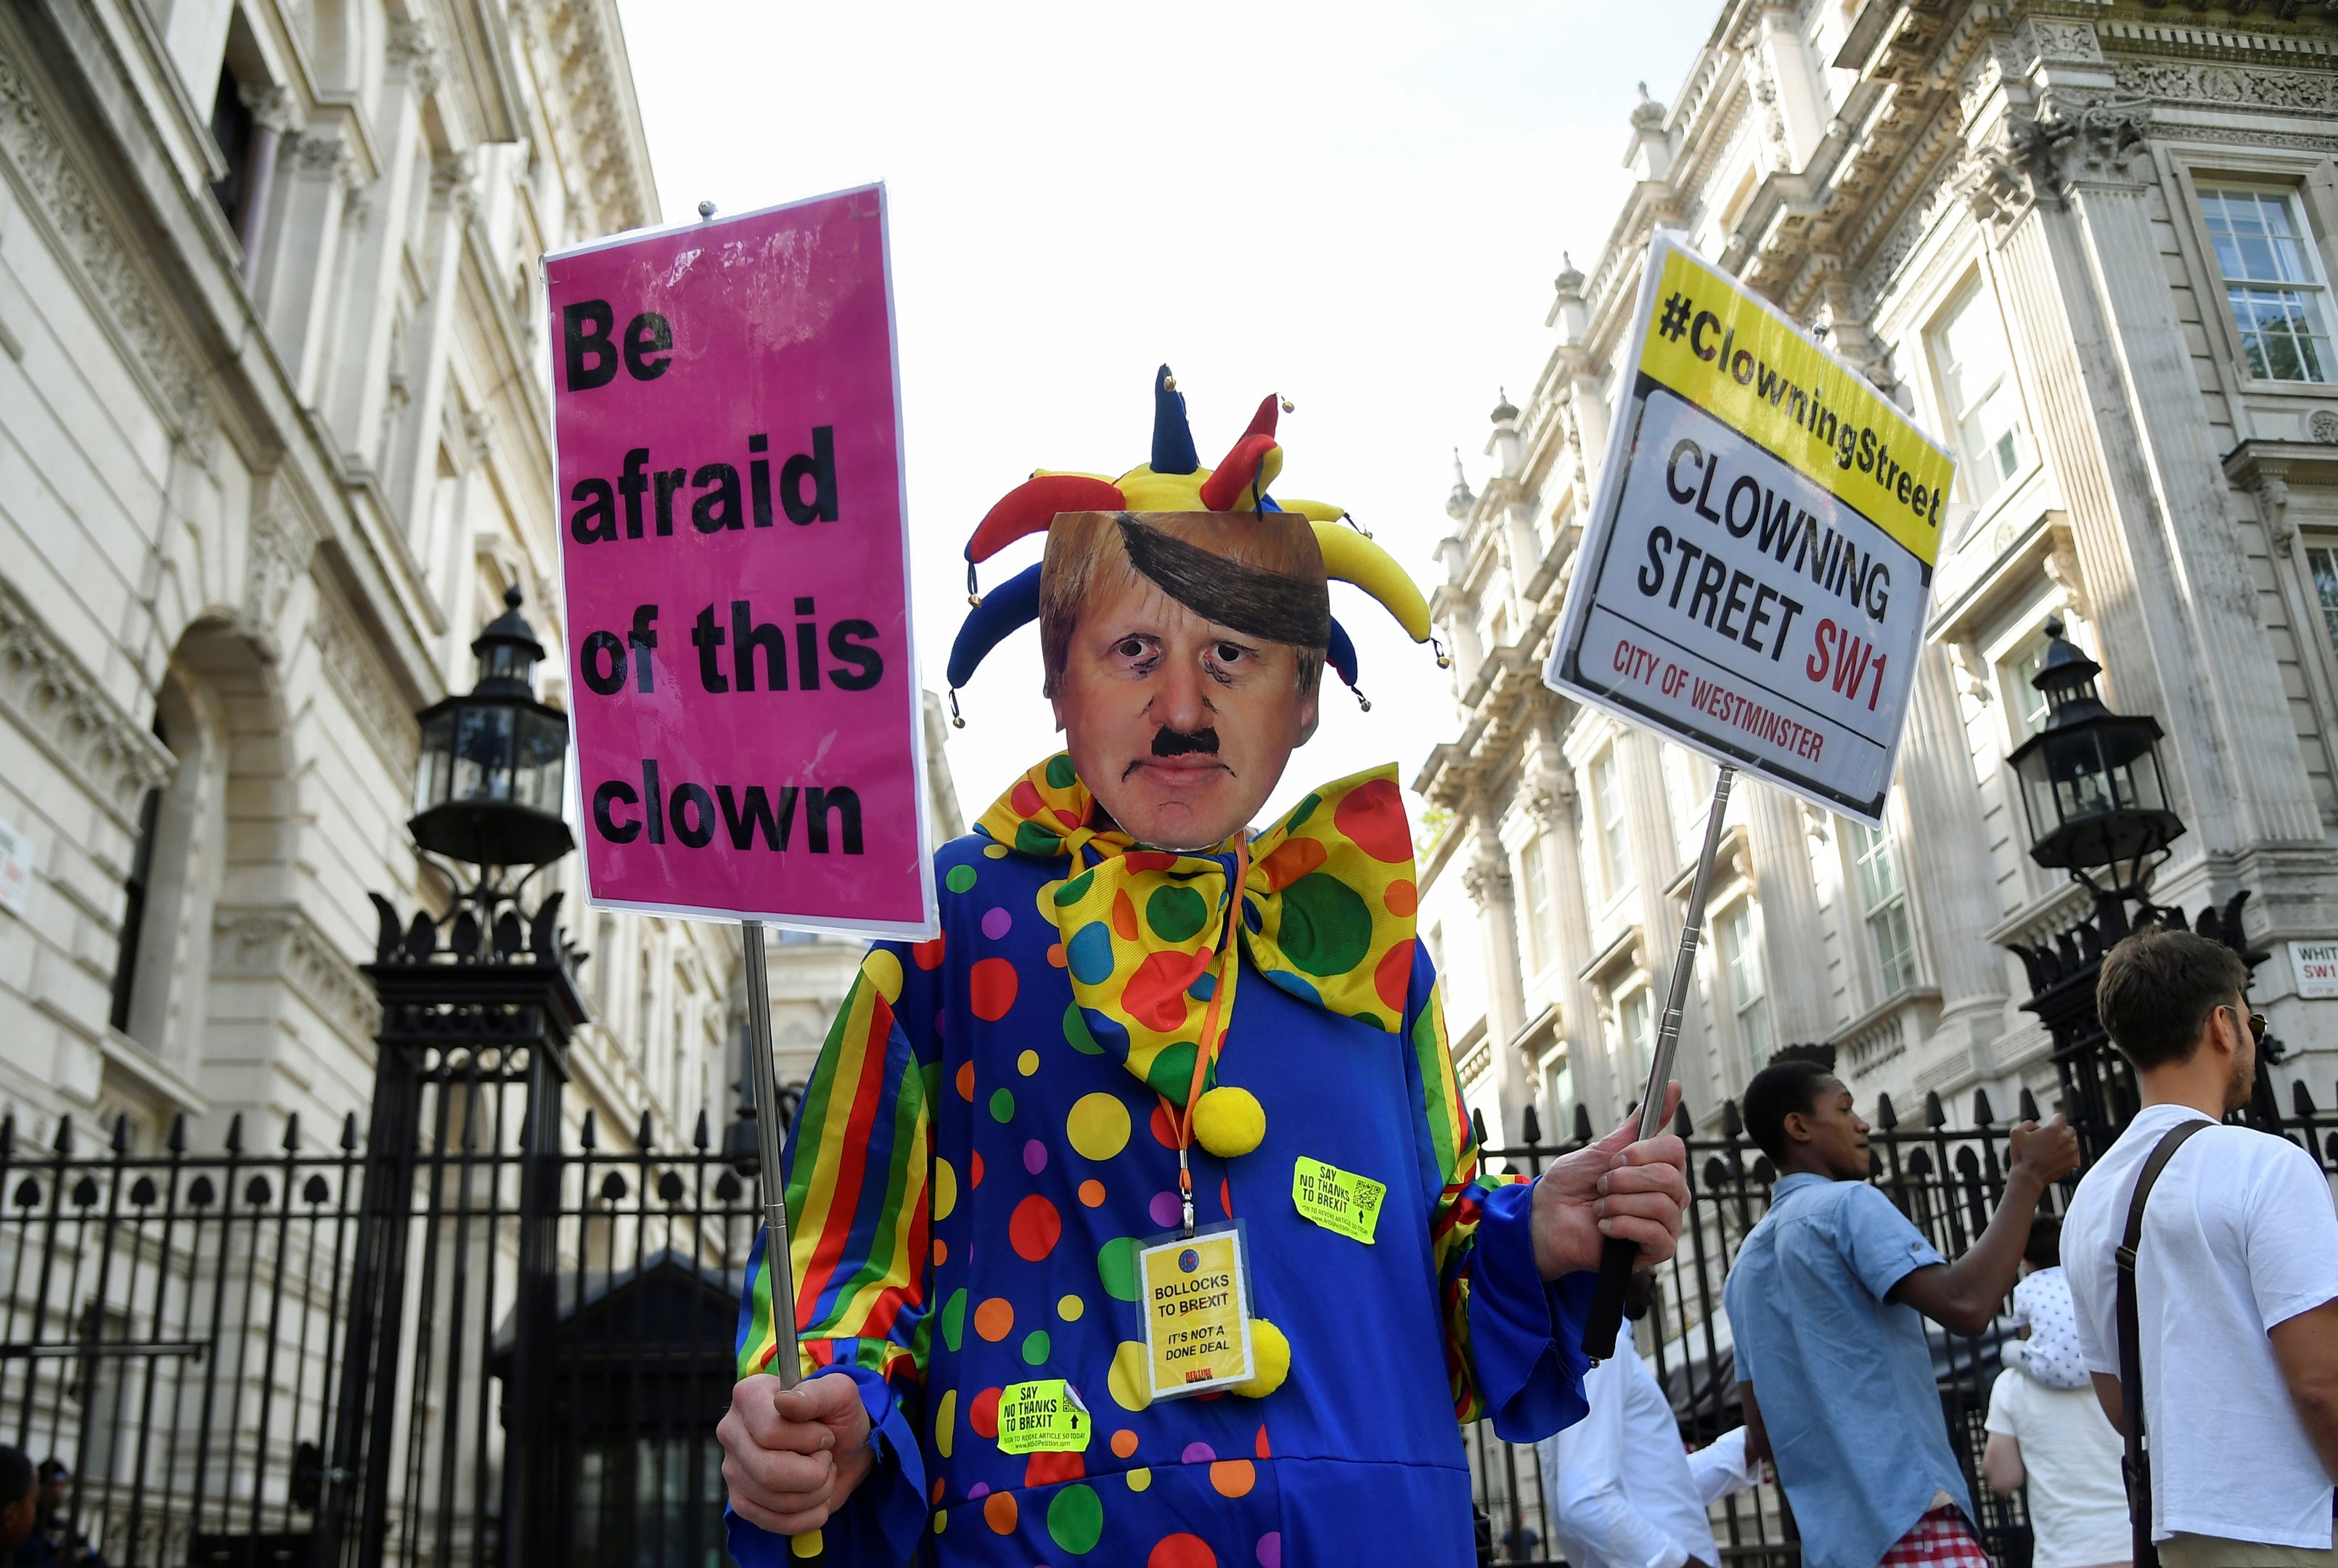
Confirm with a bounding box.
[341,589,586,1568]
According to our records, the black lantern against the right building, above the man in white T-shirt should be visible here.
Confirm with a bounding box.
[2011,617,2183,897]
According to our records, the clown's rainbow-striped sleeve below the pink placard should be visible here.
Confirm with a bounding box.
[739,942,933,1390]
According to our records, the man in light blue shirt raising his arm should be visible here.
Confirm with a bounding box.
[1721,1058,2078,1568]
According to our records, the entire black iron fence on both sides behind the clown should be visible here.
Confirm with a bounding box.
[18,1052,2338,1568]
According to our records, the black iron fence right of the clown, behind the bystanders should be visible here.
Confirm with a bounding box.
[1468,1073,2338,1568]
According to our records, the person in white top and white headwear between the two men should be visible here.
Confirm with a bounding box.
[1980,1215,2130,1568]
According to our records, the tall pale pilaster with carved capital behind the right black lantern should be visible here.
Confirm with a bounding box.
[1966,67,2321,878]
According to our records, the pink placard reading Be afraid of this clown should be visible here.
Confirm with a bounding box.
[544,184,935,935]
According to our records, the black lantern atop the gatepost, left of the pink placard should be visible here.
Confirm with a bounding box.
[406,587,575,867]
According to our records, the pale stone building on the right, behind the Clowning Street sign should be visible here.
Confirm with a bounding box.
[1417,0,2338,1154]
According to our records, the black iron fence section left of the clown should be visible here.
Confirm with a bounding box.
[0,1098,758,1568]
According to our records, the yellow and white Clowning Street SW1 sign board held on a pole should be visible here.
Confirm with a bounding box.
[1543,236,1955,825]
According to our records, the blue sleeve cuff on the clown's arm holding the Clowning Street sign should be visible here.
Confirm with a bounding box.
[1468,1183,1599,1442]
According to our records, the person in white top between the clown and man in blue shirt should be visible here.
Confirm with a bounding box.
[1536,1273,1760,1568]
